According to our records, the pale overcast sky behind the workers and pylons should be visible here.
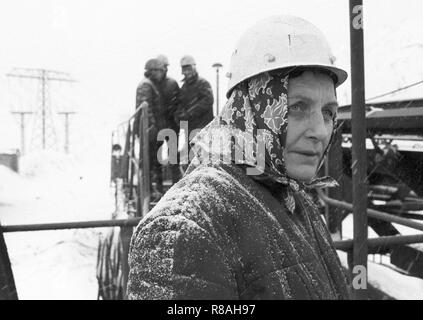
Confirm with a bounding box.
[0,0,423,154]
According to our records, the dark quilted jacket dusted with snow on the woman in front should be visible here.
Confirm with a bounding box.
[127,165,349,299]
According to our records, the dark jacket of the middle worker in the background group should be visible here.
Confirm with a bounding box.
[158,77,180,131]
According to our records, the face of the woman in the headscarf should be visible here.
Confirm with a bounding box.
[284,71,338,182]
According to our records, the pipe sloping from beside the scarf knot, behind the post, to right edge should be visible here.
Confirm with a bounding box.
[317,190,423,231]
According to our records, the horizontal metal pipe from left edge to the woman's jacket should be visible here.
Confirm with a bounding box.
[0,218,141,233]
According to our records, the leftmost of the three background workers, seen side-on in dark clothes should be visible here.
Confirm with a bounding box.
[134,59,167,201]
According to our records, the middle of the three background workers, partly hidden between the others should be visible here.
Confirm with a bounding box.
[157,54,181,183]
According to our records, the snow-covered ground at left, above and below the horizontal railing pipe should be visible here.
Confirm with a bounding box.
[0,152,114,299]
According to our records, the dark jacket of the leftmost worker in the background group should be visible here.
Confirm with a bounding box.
[134,78,166,142]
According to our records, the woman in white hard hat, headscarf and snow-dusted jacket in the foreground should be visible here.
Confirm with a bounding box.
[128,16,349,300]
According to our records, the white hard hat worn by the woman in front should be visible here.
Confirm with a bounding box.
[226,15,348,98]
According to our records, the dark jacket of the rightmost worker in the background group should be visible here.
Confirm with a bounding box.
[177,75,214,132]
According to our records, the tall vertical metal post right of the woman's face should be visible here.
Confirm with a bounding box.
[349,0,367,300]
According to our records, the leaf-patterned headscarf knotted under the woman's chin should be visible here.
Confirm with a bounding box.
[191,70,337,212]
